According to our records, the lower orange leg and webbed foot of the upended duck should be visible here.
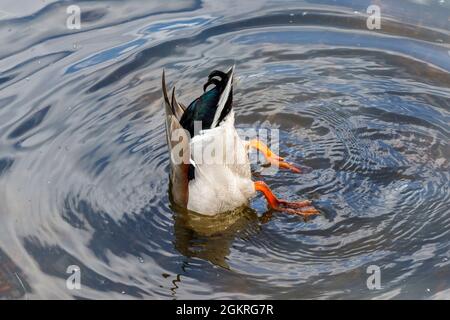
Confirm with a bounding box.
[254,181,320,218]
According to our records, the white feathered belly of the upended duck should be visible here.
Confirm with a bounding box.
[187,113,255,215]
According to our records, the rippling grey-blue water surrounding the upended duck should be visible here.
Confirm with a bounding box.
[0,0,450,299]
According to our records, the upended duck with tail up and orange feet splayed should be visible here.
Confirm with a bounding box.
[162,67,319,217]
